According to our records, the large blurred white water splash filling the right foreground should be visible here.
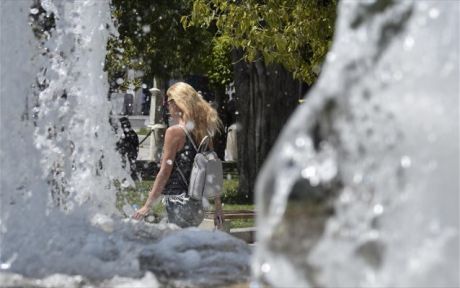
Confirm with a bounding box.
[253,1,460,287]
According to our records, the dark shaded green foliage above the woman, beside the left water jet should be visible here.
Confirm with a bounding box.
[106,0,217,90]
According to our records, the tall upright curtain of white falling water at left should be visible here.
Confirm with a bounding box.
[0,1,139,276]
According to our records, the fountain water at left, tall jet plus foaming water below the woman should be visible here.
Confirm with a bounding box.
[0,0,249,287]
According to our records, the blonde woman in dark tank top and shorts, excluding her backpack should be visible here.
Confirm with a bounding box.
[133,82,223,228]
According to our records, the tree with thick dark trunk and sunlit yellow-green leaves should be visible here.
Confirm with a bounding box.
[181,0,336,200]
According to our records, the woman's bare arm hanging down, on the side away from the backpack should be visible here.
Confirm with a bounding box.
[132,126,184,220]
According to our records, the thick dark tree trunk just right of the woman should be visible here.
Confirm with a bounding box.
[232,51,308,202]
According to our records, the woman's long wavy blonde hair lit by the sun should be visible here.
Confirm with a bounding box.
[166,82,222,145]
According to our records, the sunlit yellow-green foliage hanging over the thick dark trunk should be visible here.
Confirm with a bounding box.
[181,0,337,84]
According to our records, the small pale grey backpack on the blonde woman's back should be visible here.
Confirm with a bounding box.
[176,126,224,200]
